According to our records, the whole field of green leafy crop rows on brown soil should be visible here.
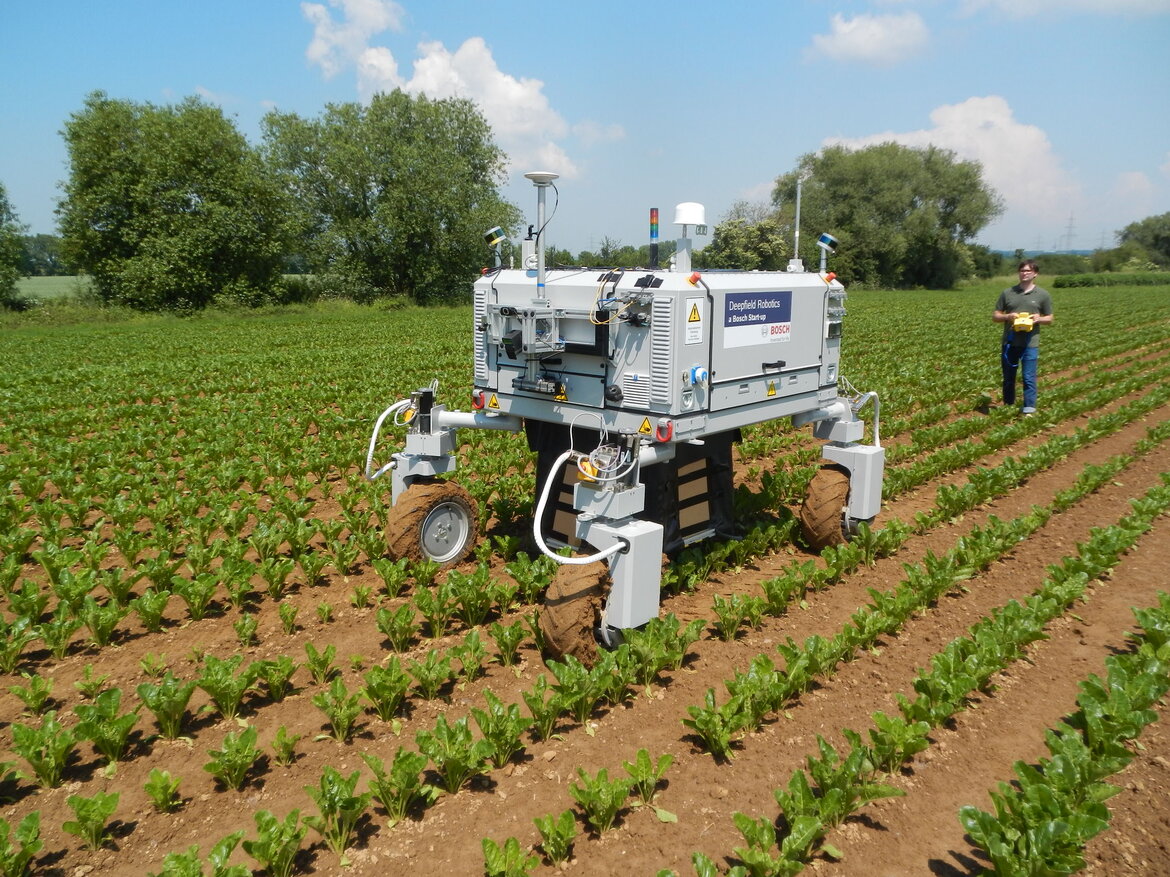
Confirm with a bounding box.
[0,283,1170,877]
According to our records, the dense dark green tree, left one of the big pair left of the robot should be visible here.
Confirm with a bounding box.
[57,91,288,310]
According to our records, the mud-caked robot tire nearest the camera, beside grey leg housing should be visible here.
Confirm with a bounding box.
[539,562,610,667]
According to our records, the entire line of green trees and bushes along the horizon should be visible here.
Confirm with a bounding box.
[0,90,1170,311]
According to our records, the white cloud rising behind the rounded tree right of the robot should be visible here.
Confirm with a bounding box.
[825,96,1080,222]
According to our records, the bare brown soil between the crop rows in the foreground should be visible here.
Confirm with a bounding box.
[0,383,1170,877]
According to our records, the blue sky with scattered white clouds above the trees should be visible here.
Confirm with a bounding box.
[0,0,1170,253]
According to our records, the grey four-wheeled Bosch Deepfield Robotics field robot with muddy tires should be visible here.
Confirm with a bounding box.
[366,172,885,663]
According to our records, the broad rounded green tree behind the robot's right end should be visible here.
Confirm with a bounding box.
[772,143,1003,289]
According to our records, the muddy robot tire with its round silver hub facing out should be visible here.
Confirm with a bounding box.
[386,481,479,568]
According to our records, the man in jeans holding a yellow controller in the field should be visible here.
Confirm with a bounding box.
[991,260,1052,416]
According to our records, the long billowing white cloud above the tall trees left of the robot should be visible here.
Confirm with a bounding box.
[302,0,575,178]
